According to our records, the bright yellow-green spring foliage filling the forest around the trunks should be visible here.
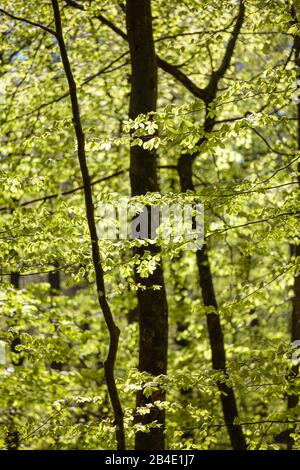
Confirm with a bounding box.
[0,0,300,450]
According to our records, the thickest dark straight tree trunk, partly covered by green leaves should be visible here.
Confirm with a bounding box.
[126,0,168,450]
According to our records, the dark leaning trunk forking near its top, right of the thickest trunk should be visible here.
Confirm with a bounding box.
[178,0,247,450]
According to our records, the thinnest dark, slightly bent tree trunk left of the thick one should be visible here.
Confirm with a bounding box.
[52,0,125,450]
